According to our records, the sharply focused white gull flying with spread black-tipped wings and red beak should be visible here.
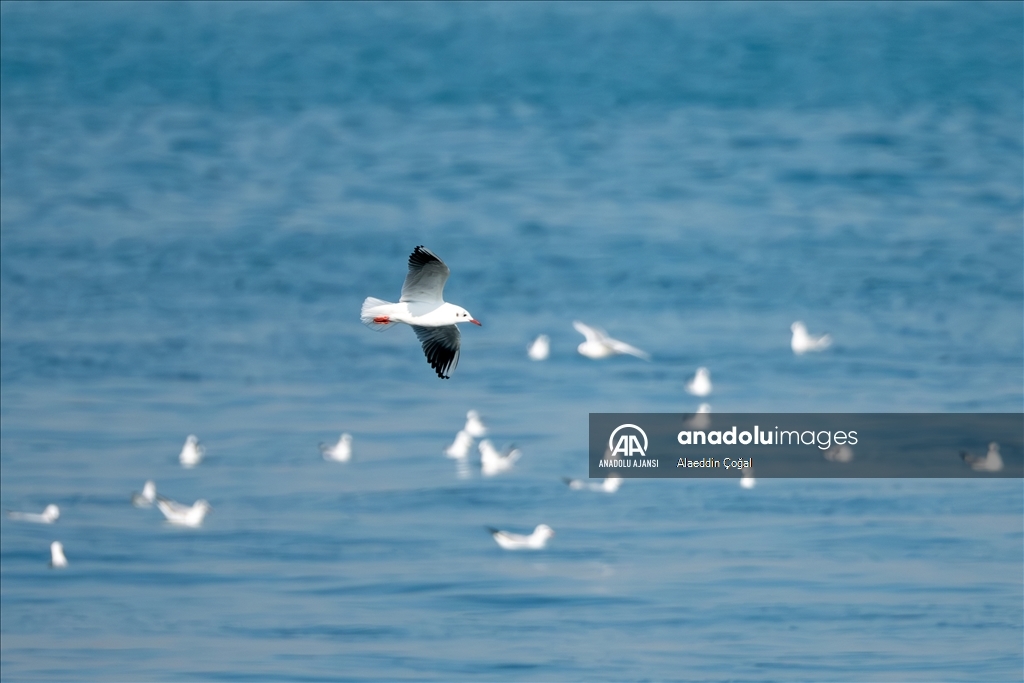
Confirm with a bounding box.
[359,246,480,380]
